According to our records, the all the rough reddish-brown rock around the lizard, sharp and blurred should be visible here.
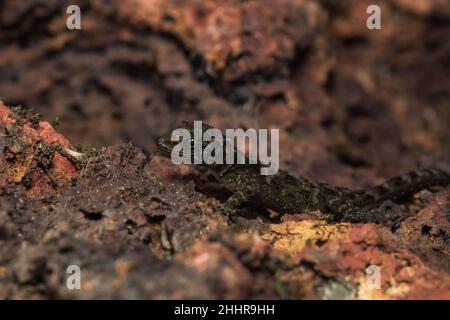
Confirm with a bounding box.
[0,0,450,299]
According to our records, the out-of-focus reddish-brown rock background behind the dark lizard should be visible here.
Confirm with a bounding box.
[0,0,450,187]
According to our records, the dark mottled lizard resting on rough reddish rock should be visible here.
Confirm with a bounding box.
[157,121,450,221]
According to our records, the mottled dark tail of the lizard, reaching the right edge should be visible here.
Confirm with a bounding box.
[364,168,450,203]
